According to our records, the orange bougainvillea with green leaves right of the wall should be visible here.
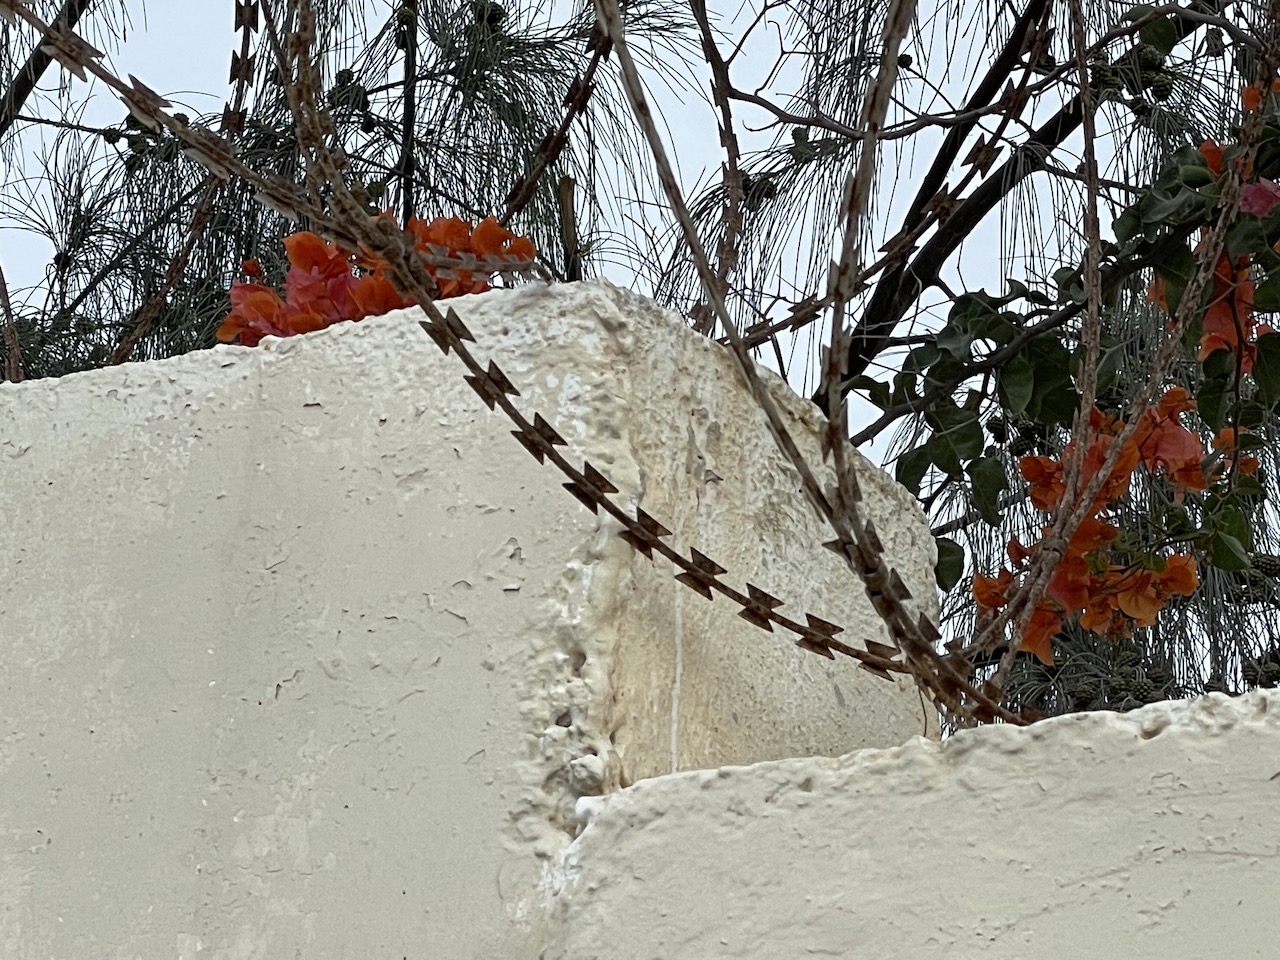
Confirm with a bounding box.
[970,82,1280,664]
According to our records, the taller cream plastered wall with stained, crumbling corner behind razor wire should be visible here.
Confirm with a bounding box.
[0,284,933,960]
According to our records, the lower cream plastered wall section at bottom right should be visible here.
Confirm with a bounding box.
[547,690,1280,960]
